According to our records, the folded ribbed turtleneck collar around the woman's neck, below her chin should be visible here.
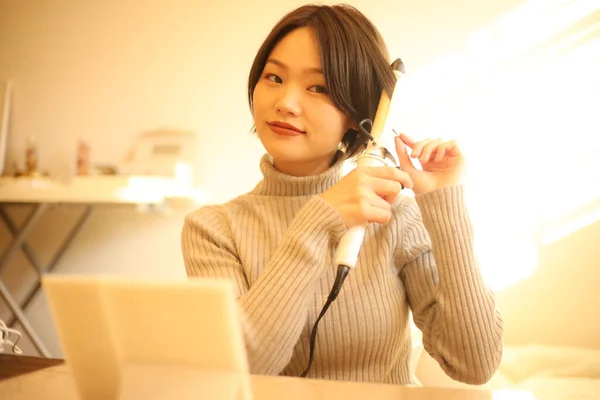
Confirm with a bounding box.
[252,154,344,196]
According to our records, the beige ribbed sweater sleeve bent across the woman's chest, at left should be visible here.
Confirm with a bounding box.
[182,196,346,375]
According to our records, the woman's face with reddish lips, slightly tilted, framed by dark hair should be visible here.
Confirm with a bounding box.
[253,27,354,176]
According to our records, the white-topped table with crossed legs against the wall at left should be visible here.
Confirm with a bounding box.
[0,175,204,357]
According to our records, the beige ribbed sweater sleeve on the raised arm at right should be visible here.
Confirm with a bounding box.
[397,186,503,384]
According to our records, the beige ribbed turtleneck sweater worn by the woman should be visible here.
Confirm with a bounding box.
[182,155,503,384]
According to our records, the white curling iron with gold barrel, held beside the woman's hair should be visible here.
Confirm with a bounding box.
[335,58,404,268]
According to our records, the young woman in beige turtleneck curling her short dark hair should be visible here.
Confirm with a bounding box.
[182,5,503,384]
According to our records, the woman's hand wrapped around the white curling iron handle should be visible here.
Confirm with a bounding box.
[321,167,413,229]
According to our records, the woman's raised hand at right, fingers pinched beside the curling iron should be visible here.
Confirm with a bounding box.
[396,133,466,194]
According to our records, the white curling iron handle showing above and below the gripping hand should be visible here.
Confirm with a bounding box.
[335,149,386,269]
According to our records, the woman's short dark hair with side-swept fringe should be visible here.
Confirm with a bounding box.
[248,4,396,159]
